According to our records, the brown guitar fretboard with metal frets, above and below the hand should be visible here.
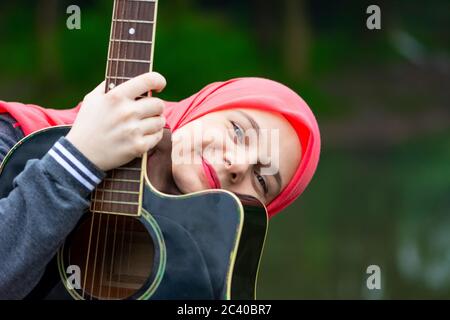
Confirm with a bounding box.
[91,0,157,216]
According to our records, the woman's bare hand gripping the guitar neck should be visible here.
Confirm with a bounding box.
[66,72,166,171]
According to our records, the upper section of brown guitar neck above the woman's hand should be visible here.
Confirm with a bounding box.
[105,0,158,92]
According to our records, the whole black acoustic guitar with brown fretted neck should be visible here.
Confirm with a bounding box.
[0,0,268,300]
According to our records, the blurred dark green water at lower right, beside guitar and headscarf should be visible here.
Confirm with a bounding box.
[258,134,450,299]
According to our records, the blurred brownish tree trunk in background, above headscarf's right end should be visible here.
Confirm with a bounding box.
[281,0,311,80]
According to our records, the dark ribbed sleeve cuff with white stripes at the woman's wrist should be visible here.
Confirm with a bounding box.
[48,137,106,191]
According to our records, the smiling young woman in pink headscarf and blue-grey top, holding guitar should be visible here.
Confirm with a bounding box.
[0,73,320,298]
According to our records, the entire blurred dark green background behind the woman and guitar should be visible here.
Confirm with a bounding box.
[0,0,450,299]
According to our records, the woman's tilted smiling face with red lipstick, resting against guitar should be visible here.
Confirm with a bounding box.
[172,109,301,204]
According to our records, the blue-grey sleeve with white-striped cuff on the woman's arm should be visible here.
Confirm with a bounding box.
[0,114,106,299]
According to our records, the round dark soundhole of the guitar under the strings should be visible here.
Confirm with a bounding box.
[64,214,155,299]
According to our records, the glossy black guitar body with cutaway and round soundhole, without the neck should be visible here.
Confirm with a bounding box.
[0,126,267,300]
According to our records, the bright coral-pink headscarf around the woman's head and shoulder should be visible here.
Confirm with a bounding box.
[0,78,320,217]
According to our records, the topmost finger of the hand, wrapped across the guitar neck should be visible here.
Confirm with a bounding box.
[110,72,166,99]
